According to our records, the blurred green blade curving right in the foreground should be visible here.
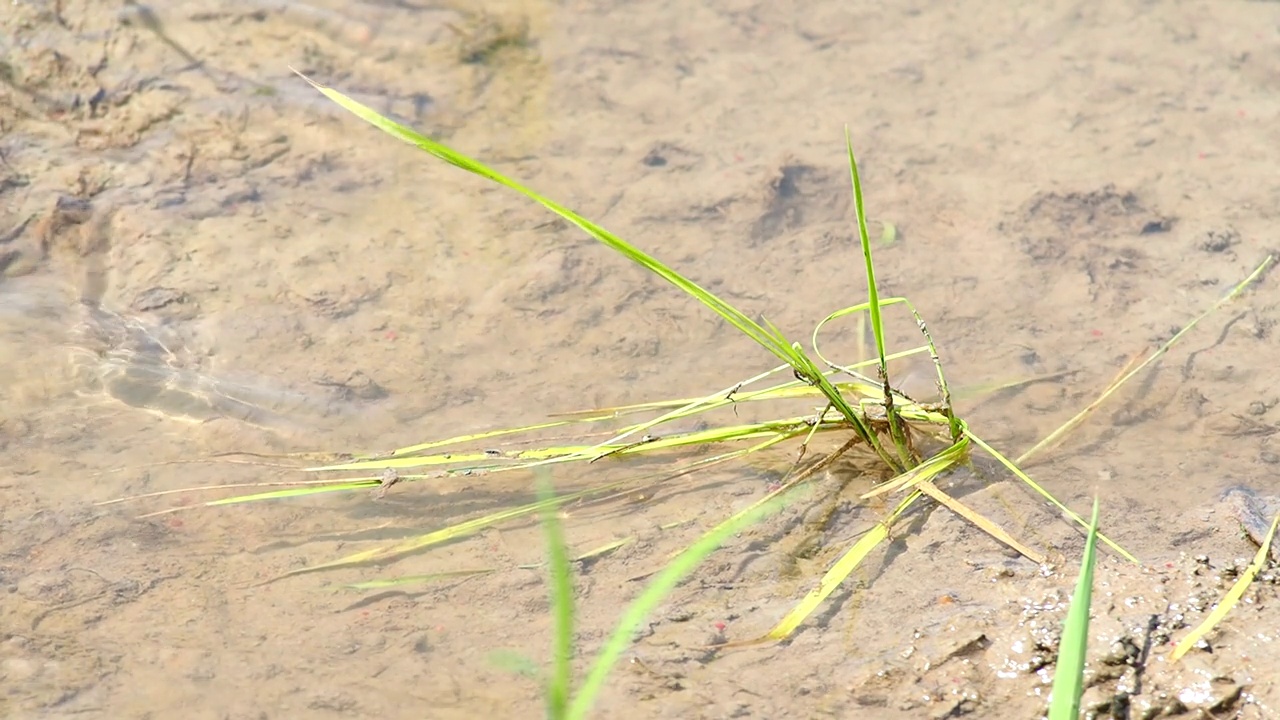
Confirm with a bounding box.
[567,484,786,720]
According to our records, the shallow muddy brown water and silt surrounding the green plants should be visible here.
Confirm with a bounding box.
[0,0,1280,717]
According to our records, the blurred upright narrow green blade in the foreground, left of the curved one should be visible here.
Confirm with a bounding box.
[538,470,573,720]
